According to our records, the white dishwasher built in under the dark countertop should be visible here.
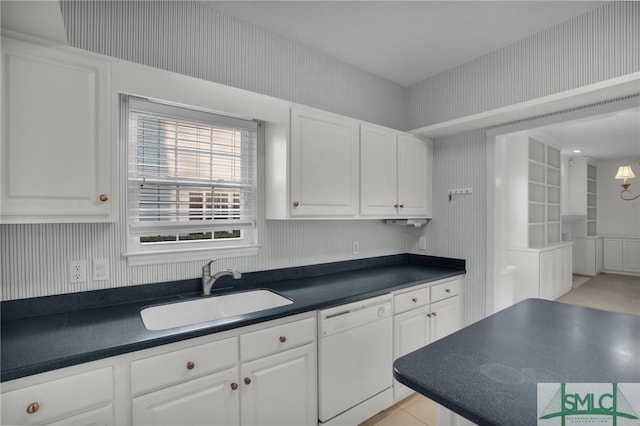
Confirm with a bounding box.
[318,295,393,426]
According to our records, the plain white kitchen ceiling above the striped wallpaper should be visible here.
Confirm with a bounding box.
[200,0,607,86]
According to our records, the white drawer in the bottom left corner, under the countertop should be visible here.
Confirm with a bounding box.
[2,367,113,425]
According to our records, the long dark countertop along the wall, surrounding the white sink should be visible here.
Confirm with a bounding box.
[0,254,465,382]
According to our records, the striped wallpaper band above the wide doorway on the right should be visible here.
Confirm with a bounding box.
[407,1,640,129]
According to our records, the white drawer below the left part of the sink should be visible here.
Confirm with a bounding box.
[131,337,238,395]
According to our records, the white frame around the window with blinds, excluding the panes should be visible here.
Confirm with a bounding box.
[119,93,261,266]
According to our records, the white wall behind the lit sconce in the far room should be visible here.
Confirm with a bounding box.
[596,160,640,236]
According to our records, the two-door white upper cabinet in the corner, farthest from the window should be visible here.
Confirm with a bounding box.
[360,125,433,219]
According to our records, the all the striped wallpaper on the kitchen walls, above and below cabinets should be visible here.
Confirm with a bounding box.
[0,0,640,323]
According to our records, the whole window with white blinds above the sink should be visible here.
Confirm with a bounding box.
[122,96,257,264]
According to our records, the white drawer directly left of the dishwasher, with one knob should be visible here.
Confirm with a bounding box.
[240,318,317,361]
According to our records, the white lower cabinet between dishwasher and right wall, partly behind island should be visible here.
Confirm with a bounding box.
[393,278,462,402]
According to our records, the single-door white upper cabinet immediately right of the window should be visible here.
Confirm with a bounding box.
[265,107,360,219]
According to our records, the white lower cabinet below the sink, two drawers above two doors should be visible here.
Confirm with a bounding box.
[131,315,318,426]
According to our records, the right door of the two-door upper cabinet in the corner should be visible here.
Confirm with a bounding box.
[398,134,432,217]
